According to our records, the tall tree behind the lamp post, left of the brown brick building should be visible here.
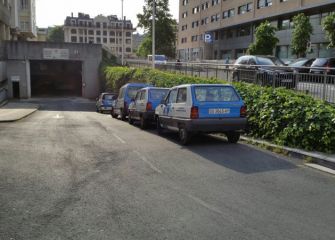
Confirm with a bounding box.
[137,0,177,58]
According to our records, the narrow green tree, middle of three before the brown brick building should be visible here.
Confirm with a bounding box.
[291,13,313,58]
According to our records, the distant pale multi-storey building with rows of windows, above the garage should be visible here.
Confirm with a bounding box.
[64,13,135,57]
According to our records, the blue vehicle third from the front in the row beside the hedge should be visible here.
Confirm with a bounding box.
[111,83,150,120]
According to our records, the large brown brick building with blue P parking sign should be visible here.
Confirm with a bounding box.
[177,0,335,61]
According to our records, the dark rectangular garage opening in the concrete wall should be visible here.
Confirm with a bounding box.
[30,60,82,97]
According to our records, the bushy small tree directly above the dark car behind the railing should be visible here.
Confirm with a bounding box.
[248,21,279,55]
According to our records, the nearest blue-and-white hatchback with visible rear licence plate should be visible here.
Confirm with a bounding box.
[155,84,247,144]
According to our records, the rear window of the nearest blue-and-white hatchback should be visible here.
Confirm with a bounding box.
[195,86,240,102]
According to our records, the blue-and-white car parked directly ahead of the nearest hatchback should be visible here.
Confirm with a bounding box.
[128,87,169,129]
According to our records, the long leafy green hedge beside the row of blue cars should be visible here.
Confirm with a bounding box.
[105,67,335,152]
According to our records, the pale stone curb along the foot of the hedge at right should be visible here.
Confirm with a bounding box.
[241,136,335,170]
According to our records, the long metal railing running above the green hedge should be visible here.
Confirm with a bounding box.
[127,59,335,103]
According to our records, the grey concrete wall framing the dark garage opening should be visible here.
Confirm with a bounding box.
[5,42,102,98]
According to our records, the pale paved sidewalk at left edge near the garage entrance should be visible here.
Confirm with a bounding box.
[0,102,39,123]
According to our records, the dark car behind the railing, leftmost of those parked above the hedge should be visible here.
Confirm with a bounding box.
[232,55,296,88]
